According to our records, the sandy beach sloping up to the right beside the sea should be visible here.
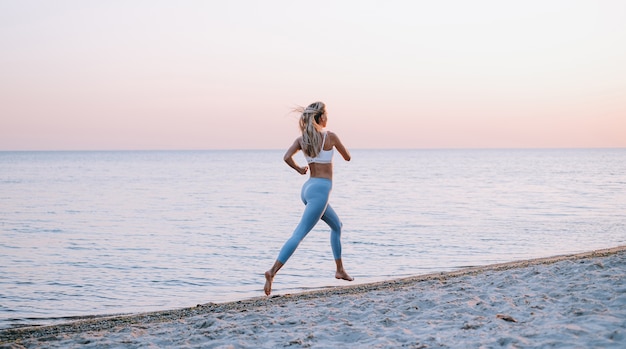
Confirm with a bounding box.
[0,246,626,348]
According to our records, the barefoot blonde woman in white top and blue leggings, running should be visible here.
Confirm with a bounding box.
[263,102,354,296]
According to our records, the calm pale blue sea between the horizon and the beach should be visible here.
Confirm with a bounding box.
[0,149,626,328]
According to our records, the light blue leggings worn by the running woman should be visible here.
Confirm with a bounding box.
[278,177,342,264]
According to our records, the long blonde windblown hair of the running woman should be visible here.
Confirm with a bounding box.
[294,102,326,158]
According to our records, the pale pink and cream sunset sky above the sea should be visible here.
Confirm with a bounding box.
[0,0,626,151]
